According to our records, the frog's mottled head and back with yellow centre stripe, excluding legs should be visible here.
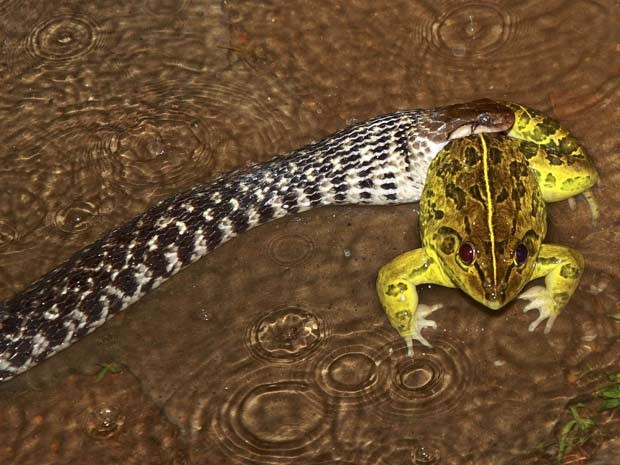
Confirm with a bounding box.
[420,135,546,309]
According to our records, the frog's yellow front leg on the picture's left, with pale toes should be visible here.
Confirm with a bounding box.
[377,249,455,356]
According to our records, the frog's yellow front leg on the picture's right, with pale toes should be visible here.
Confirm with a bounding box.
[518,244,583,333]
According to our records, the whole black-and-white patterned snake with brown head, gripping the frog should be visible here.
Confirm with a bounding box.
[0,100,514,381]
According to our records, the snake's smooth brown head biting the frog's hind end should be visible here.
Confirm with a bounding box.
[436,99,515,140]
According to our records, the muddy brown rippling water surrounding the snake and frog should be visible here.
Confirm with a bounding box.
[0,0,620,465]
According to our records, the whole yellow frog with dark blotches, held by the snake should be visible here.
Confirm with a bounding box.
[376,102,599,356]
